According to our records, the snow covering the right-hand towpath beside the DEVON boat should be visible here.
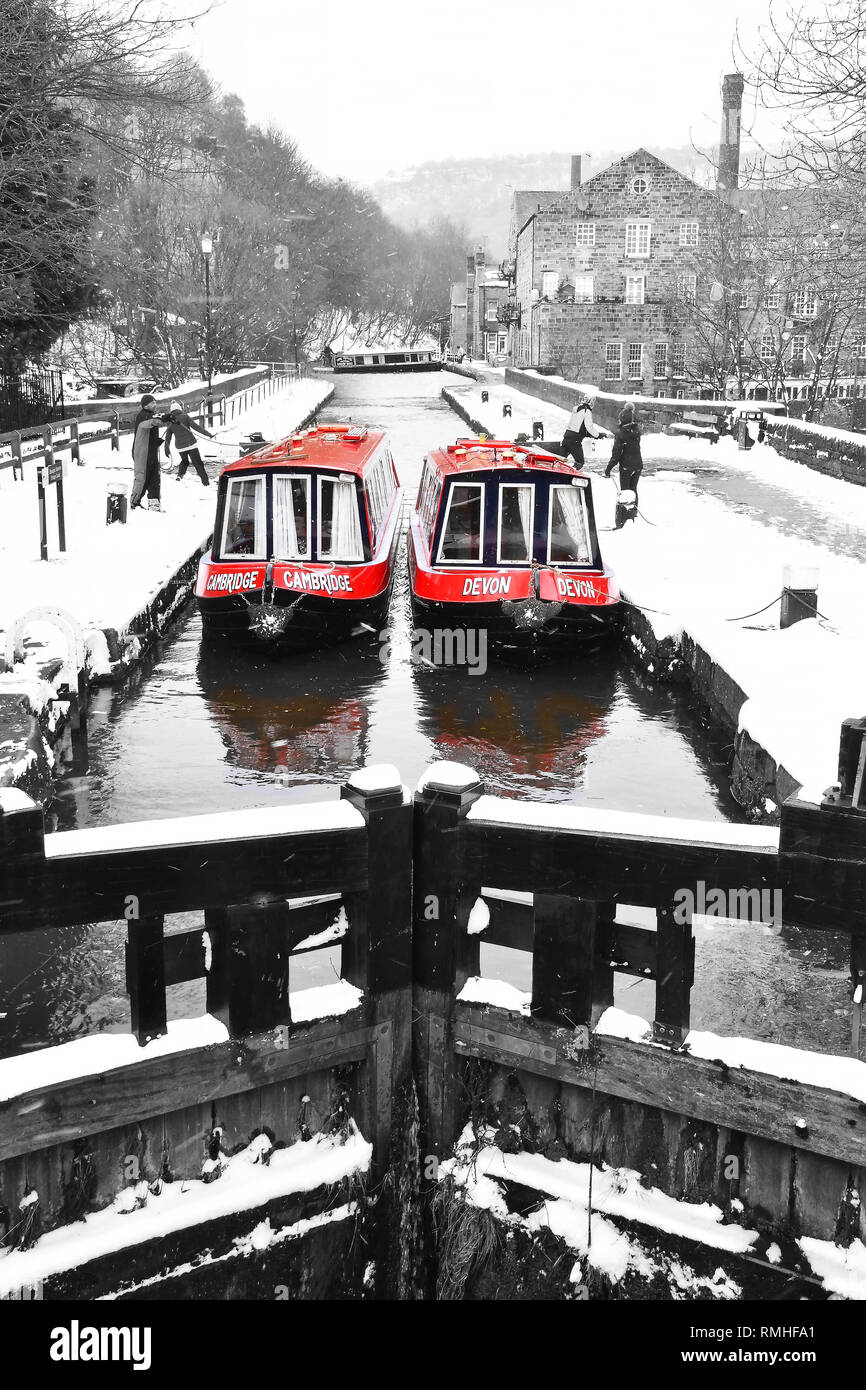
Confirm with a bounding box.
[455,378,866,799]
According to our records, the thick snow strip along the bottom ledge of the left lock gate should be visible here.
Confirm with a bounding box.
[0,1120,373,1298]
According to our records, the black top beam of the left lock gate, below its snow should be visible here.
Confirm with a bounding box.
[0,812,367,931]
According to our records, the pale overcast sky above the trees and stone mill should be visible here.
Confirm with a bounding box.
[192,0,783,182]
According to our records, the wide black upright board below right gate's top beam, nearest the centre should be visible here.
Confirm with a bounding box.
[532,892,613,1029]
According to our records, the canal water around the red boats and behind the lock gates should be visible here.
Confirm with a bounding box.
[0,373,849,1056]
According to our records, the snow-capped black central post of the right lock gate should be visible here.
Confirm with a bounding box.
[413,762,484,1159]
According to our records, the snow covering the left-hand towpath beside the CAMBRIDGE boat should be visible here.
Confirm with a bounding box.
[0,379,329,674]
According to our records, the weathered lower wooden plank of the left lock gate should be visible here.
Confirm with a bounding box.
[0,1009,375,1159]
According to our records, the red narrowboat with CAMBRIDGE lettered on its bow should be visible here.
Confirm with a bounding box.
[196,425,402,649]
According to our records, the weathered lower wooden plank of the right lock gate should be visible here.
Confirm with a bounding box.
[455,1004,866,1166]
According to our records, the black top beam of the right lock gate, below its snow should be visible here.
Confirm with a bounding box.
[463,820,780,908]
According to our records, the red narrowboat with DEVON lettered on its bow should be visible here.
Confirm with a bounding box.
[409,439,620,656]
